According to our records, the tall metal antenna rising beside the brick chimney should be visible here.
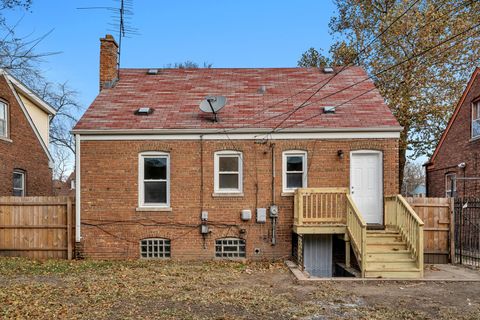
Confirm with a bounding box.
[77,0,139,79]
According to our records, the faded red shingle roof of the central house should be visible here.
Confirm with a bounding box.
[73,67,401,133]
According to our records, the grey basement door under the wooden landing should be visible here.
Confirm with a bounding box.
[303,234,333,278]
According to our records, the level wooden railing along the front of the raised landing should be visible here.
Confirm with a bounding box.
[294,188,348,226]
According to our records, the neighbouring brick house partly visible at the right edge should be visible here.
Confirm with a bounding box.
[425,68,480,197]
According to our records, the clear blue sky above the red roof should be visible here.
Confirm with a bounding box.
[2,0,334,107]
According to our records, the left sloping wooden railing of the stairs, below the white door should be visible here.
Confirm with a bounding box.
[346,195,367,278]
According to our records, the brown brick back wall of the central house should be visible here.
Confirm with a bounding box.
[81,139,398,259]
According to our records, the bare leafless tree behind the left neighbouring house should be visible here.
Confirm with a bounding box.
[0,0,83,180]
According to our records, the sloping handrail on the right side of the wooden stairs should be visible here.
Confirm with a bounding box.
[389,194,424,277]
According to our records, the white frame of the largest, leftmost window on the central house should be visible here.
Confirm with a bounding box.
[138,151,170,208]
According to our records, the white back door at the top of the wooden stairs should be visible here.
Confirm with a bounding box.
[350,151,383,224]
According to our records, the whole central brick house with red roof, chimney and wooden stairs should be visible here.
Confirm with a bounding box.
[73,36,423,277]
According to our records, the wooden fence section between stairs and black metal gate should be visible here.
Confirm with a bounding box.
[406,198,454,263]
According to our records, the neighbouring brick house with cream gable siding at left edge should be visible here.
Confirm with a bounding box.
[0,69,55,196]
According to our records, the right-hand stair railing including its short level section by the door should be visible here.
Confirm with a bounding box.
[385,195,423,277]
